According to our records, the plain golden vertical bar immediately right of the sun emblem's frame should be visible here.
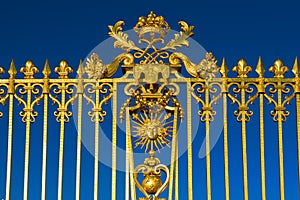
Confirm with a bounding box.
[186,81,193,200]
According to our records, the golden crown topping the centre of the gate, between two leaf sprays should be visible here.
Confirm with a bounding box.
[134,11,170,41]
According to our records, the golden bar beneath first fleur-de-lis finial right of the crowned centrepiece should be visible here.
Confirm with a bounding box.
[241,82,248,200]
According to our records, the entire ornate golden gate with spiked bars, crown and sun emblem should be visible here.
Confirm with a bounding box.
[0,12,300,200]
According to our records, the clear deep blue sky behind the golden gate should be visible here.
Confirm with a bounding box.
[0,0,300,200]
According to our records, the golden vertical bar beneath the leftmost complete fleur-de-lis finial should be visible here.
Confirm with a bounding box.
[23,83,31,200]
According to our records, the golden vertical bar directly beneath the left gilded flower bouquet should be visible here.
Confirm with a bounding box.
[94,82,100,200]
